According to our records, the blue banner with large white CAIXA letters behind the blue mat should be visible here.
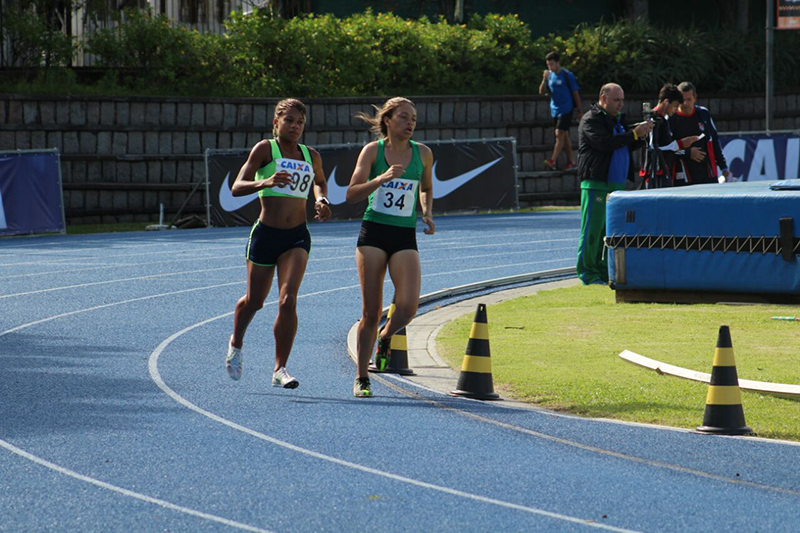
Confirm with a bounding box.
[719,134,800,181]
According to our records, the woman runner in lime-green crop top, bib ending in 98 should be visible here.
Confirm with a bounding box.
[225,99,331,389]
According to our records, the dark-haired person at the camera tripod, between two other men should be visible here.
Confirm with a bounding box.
[639,83,698,189]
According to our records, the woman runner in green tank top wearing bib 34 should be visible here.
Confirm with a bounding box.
[347,97,436,397]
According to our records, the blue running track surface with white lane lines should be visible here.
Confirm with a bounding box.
[0,211,800,532]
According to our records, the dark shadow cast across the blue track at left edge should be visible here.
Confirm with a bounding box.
[0,333,182,439]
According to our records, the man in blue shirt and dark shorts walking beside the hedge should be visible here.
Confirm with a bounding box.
[539,52,581,171]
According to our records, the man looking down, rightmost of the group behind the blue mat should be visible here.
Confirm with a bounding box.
[669,81,731,185]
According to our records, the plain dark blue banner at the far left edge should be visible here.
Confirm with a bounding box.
[0,152,65,236]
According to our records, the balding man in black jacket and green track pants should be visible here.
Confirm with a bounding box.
[577,83,653,285]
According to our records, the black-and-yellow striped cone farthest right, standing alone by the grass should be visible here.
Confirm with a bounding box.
[697,326,753,435]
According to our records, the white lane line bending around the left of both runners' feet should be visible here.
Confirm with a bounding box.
[147,308,633,532]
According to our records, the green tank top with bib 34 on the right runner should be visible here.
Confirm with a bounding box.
[364,139,424,228]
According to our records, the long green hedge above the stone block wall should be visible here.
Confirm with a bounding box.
[2,10,800,97]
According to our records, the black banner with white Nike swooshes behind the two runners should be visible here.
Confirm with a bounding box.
[206,137,518,227]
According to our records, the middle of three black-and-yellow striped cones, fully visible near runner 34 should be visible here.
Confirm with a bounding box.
[450,304,500,400]
